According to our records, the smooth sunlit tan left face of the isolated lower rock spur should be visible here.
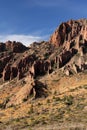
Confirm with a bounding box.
[6,76,35,107]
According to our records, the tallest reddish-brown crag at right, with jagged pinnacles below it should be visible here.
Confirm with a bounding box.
[50,19,87,73]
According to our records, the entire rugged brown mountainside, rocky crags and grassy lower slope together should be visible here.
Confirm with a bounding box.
[0,19,87,130]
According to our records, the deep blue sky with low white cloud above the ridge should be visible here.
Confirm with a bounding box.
[0,0,87,46]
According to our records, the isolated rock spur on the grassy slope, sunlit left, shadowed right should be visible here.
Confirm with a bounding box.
[6,75,48,107]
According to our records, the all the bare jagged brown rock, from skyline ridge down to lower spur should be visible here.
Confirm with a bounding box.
[0,20,87,107]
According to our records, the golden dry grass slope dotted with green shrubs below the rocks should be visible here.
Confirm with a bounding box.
[0,73,87,130]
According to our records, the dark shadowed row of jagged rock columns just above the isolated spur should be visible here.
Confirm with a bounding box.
[3,56,52,81]
